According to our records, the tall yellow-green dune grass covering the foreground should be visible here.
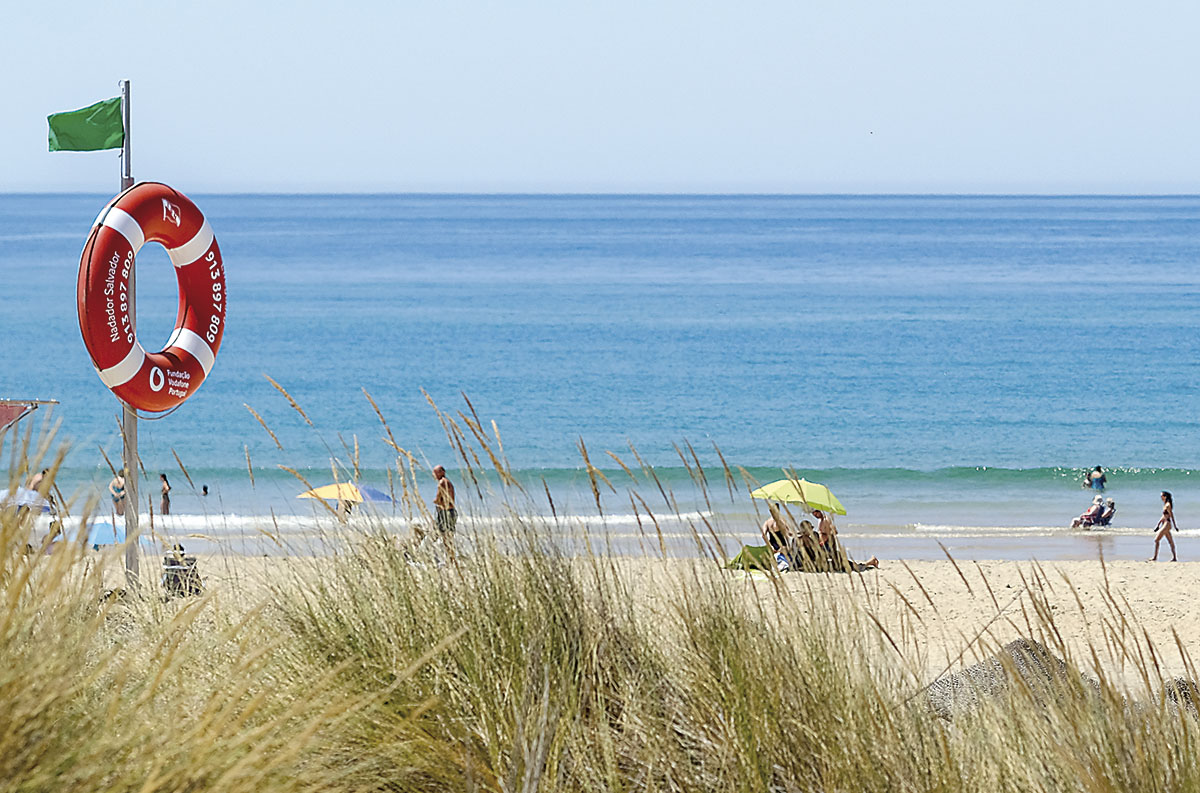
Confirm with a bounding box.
[0,410,1200,793]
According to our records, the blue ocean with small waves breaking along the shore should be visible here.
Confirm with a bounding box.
[0,194,1200,558]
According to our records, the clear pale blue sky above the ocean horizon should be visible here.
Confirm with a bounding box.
[0,0,1200,193]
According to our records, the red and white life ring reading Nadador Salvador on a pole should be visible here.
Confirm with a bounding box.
[76,182,226,413]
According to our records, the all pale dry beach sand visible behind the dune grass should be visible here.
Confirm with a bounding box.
[144,553,1200,690]
